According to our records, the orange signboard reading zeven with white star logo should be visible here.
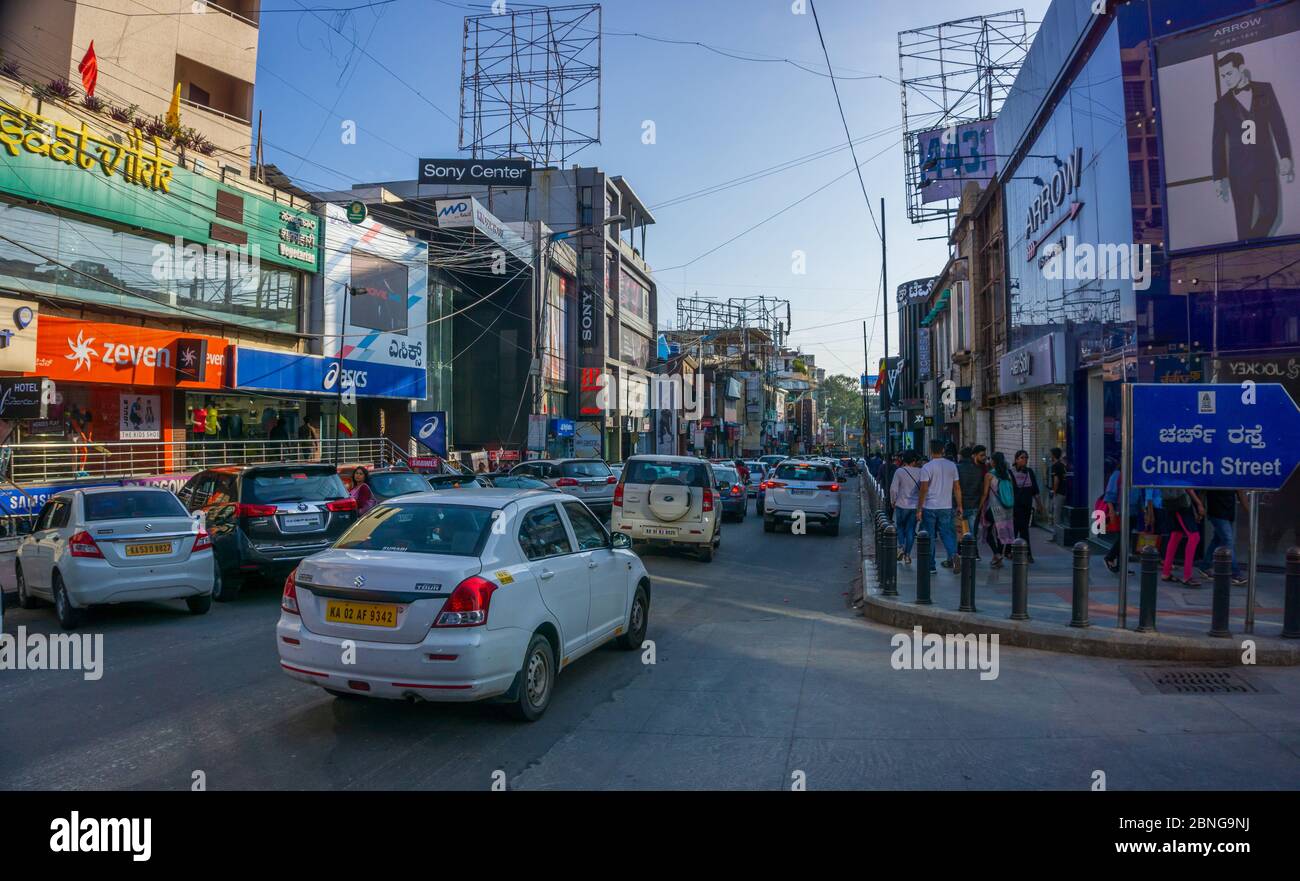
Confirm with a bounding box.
[35,314,228,389]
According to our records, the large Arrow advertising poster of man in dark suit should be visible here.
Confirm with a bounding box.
[1156,3,1300,251]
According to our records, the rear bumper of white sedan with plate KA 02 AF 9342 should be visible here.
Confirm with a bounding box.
[276,611,532,700]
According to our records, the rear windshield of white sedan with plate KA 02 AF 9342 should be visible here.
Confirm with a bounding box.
[334,502,493,556]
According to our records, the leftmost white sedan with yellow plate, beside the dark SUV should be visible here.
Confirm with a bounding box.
[14,486,216,630]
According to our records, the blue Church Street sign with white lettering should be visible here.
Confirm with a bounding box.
[1132,383,1300,490]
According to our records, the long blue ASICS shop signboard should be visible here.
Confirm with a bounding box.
[230,346,426,400]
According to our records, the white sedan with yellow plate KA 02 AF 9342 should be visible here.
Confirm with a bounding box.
[276,489,650,721]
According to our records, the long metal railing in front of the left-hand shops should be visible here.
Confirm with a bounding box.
[9,438,408,486]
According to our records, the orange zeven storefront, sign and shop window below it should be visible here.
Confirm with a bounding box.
[26,314,229,457]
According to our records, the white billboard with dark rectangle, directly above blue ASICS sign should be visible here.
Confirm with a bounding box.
[322,205,429,382]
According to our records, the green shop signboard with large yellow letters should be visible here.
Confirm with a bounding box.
[0,101,320,272]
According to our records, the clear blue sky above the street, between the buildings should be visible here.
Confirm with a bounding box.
[256,0,1048,374]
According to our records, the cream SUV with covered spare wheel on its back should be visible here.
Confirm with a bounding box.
[611,455,722,563]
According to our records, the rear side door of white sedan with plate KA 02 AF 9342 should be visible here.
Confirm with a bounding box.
[519,503,592,663]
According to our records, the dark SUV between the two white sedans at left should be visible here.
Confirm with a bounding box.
[177,463,356,603]
